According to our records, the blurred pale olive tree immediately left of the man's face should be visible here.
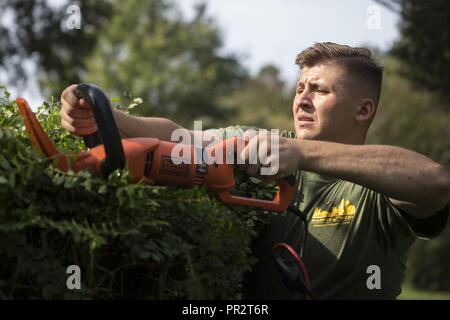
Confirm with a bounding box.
[222,65,295,130]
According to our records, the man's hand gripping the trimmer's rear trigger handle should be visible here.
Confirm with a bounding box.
[238,131,301,181]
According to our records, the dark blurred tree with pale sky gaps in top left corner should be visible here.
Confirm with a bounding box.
[0,0,112,96]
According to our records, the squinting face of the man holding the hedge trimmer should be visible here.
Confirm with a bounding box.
[292,63,354,143]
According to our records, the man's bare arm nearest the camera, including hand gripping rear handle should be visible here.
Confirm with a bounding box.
[241,135,450,219]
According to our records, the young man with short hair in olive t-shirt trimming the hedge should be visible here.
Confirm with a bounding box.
[61,43,450,299]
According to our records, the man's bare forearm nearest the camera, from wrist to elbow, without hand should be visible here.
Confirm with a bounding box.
[298,141,450,216]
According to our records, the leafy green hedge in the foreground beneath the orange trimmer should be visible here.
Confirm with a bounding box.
[0,88,270,299]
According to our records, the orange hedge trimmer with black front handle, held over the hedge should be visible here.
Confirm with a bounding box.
[16,84,298,212]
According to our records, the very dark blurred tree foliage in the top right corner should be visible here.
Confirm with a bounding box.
[377,0,450,107]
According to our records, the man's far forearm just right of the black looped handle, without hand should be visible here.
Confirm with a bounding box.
[113,109,183,141]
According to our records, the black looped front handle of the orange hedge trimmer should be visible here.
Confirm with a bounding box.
[75,83,125,177]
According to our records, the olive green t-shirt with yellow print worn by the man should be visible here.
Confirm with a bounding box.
[208,127,448,299]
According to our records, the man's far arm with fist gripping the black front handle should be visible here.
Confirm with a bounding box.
[61,85,193,141]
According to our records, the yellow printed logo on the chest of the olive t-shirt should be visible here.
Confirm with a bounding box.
[311,199,356,227]
